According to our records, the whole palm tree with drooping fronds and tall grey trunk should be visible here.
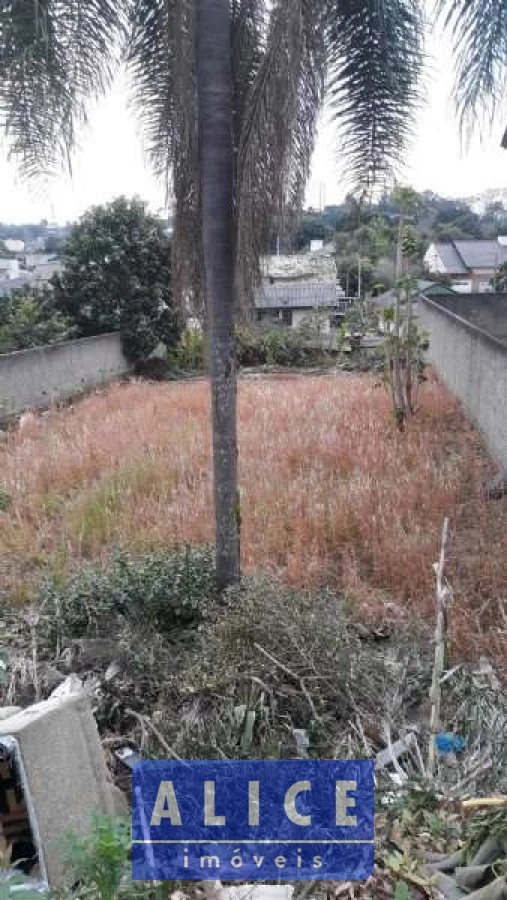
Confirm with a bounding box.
[0,0,507,588]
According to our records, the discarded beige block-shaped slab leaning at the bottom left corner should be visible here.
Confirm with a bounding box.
[0,693,117,887]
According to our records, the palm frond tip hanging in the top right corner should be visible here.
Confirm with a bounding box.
[437,0,507,136]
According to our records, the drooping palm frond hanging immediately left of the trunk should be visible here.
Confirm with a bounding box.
[126,0,203,316]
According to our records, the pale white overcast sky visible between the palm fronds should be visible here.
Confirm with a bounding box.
[0,22,507,222]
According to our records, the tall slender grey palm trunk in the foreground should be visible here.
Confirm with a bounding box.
[196,0,240,591]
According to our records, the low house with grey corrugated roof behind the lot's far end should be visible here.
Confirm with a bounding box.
[255,281,350,331]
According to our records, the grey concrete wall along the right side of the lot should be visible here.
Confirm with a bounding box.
[418,294,507,472]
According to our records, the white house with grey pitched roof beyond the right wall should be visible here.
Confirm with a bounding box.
[424,237,507,294]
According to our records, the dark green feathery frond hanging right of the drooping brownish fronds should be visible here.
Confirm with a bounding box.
[327,0,423,193]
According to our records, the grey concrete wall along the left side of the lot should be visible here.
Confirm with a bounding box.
[0,334,128,421]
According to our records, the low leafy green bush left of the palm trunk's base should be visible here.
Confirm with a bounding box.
[38,548,215,649]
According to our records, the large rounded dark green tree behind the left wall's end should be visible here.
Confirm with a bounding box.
[53,197,180,361]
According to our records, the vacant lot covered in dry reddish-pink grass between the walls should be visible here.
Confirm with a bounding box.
[0,376,507,676]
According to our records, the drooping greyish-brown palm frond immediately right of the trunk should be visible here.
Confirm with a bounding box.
[236,0,325,309]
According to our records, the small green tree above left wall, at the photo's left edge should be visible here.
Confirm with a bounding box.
[0,287,74,353]
